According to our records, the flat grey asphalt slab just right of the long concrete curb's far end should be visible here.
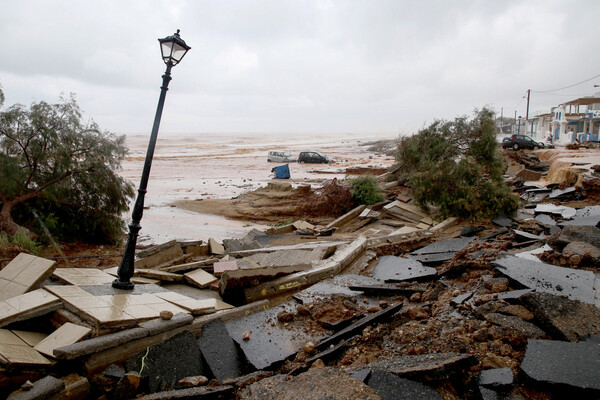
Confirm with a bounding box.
[372,256,437,283]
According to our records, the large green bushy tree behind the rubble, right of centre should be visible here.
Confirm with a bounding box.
[396,108,518,220]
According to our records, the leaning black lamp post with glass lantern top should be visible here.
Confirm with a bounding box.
[112,29,191,290]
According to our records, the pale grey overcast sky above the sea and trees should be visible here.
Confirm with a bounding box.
[0,0,600,136]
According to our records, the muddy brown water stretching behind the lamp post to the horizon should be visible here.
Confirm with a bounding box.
[121,134,394,245]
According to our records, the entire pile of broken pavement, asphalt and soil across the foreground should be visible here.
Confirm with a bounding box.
[0,148,600,399]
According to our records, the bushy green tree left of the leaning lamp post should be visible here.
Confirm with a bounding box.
[0,89,134,241]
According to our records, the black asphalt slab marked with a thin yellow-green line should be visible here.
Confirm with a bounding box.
[124,331,207,393]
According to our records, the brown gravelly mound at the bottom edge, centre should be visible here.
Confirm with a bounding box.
[239,367,380,400]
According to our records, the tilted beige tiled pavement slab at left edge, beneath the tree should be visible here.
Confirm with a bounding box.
[0,253,55,300]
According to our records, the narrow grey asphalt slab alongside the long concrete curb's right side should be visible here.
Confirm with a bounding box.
[292,274,379,304]
